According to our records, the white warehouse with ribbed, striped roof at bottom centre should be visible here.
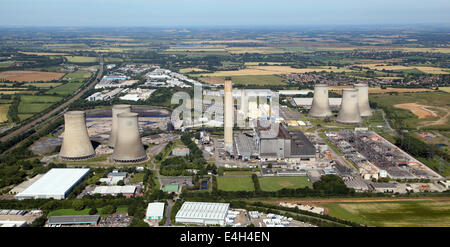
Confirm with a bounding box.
[175,202,230,226]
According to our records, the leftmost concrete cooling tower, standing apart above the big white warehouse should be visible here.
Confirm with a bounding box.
[59,111,95,160]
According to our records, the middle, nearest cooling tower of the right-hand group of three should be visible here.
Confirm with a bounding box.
[336,88,361,124]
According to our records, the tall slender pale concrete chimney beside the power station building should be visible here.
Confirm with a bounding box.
[223,80,233,154]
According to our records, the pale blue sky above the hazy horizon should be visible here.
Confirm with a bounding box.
[0,0,450,27]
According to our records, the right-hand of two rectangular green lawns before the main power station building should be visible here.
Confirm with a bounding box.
[259,177,312,191]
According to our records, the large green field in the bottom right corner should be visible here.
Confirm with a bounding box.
[323,200,450,227]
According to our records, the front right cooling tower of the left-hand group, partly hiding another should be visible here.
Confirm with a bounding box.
[112,112,147,162]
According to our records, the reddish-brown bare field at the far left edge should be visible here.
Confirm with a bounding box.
[0,70,64,82]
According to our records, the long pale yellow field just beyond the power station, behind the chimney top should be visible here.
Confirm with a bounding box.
[202,66,349,76]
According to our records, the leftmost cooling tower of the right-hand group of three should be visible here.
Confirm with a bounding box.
[308,84,333,118]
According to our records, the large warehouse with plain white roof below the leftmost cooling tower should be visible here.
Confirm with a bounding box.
[16,168,89,200]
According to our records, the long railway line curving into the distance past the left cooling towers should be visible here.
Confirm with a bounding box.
[0,56,103,152]
